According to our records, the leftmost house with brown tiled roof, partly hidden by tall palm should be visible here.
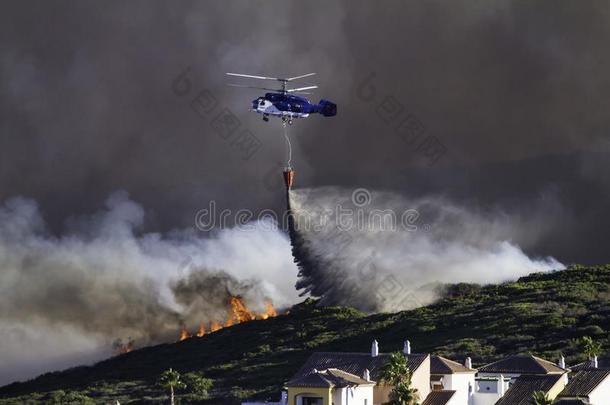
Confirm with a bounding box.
[285,340,428,405]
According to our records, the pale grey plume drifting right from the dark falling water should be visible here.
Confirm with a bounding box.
[289,187,563,311]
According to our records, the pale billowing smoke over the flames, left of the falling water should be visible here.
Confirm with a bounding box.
[0,192,296,383]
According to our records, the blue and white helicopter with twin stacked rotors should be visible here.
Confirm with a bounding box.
[227,73,337,125]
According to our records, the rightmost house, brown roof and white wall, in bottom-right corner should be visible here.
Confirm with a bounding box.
[558,369,610,405]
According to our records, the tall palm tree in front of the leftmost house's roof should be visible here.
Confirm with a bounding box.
[380,352,419,405]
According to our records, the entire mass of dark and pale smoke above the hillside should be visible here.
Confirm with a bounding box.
[0,0,610,388]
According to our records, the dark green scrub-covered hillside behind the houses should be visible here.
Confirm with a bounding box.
[0,265,610,404]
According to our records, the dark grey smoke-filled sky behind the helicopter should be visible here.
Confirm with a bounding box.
[0,1,610,263]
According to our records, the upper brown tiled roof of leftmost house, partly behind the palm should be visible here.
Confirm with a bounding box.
[292,352,428,380]
